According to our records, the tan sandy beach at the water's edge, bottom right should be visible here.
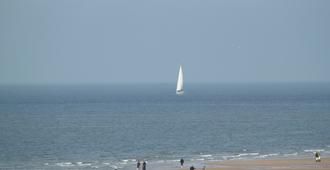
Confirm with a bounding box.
[201,158,330,170]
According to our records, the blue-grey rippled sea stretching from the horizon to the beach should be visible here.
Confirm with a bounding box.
[0,83,330,170]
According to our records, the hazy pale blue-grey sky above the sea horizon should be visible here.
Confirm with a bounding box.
[0,0,330,85]
